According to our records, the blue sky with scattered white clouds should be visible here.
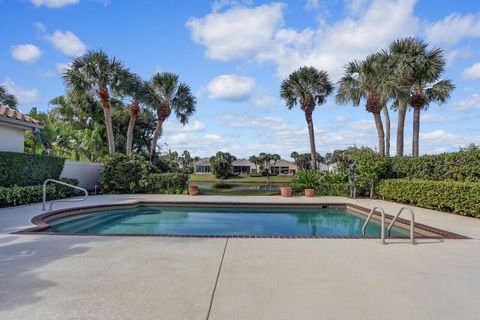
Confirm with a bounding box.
[0,0,480,158]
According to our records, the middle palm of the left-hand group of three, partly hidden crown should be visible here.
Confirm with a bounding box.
[119,70,147,154]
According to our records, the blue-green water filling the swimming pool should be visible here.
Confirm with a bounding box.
[48,206,408,236]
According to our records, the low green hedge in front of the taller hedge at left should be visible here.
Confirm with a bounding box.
[0,178,78,207]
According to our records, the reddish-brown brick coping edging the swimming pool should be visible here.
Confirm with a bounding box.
[12,200,471,239]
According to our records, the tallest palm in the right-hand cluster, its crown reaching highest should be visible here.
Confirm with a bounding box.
[388,37,428,156]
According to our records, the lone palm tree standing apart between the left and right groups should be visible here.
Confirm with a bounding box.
[280,67,333,169]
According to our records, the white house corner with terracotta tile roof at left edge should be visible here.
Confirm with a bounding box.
[0,104,43,153]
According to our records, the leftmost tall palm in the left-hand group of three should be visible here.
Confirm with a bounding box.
[62,50,125,154]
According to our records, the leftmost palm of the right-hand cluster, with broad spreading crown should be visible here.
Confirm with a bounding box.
[336,54,396,156]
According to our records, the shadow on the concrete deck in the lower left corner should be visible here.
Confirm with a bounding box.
[0,236,102,311]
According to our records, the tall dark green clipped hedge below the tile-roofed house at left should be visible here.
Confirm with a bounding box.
[0,151,65,187]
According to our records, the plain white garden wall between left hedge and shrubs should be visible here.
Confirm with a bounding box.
[60,160,103,190]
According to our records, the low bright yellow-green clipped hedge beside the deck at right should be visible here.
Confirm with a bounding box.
[377,179,480,218]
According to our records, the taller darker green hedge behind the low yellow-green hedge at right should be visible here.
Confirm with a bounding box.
[386,149,480,181]
